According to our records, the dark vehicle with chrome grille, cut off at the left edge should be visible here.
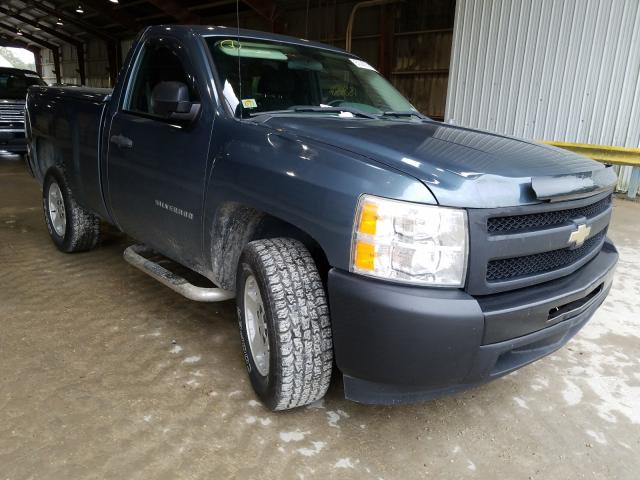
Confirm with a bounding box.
[0,67,46,154]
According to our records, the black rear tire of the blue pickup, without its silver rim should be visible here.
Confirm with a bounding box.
[42,168,100,253]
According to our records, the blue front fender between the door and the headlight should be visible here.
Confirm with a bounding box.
[204,120,436,281]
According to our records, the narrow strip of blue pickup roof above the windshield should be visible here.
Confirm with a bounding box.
[148,25,355,56]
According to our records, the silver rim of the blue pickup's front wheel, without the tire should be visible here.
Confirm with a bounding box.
[244,275,269,377]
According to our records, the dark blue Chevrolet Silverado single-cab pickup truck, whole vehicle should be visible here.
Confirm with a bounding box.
[26,26,618,410]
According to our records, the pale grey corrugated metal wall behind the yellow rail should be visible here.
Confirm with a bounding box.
[445,0,640,190]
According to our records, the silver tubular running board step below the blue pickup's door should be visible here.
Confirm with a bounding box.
[123,245,235,302]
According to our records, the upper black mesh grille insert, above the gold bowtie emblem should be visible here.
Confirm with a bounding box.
[487,195,611,235]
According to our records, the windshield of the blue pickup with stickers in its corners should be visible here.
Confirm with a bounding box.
[206,37,417,116]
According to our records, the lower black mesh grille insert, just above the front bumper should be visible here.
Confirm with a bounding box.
[487,228,606,282]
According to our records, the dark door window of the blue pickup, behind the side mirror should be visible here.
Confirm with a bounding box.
[124,42,200,115]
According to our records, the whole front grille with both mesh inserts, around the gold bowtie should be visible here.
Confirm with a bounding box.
[465,193,613,295]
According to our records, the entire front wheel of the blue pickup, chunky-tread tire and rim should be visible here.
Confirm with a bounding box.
[236,238,333,410]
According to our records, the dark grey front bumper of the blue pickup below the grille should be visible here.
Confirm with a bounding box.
[329,240,618,404]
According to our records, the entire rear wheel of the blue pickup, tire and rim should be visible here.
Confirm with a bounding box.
[42,170,100,253]
